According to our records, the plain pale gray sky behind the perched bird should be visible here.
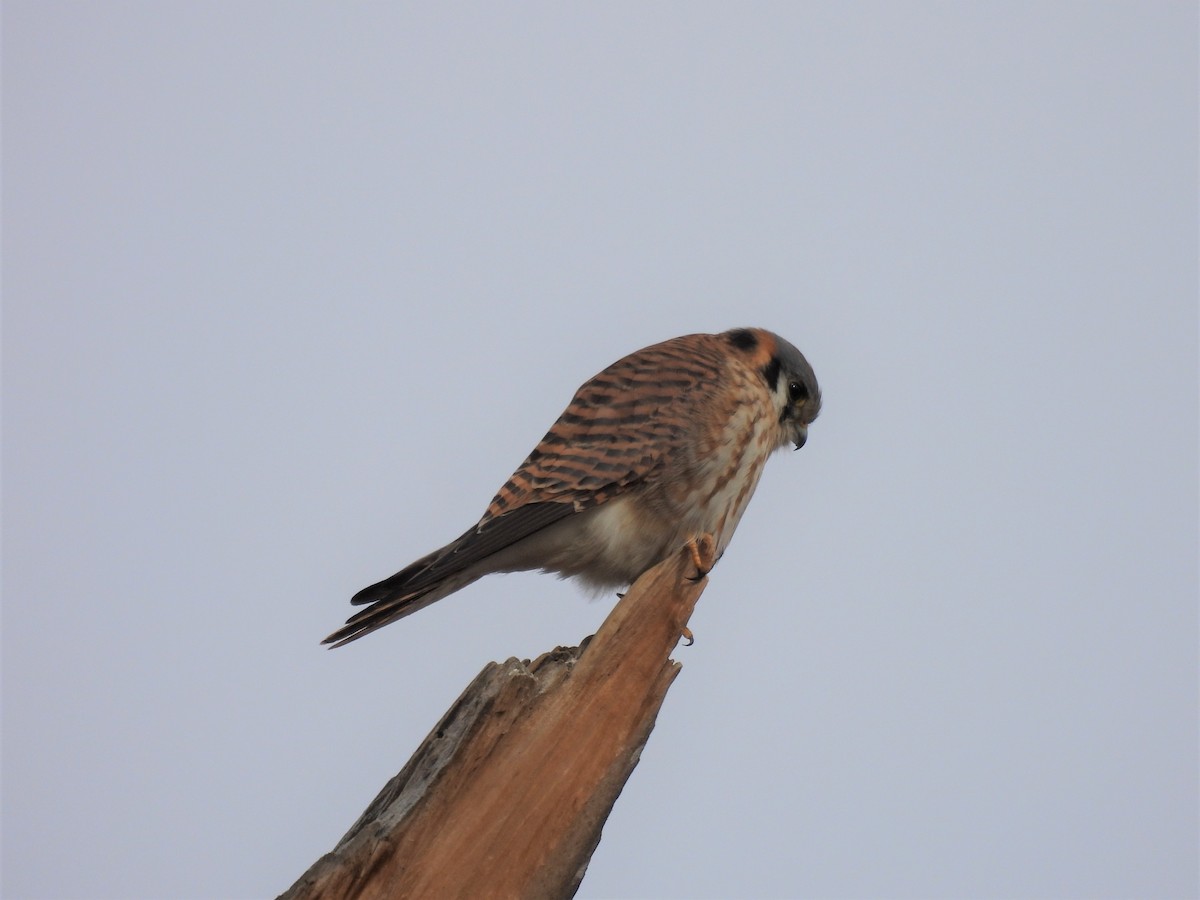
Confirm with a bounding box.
[2,0,1200,900]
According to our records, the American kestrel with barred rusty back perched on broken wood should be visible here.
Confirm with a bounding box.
[322,328,821,647]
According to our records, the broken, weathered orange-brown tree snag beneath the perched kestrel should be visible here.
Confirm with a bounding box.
[281,536,714,900]
